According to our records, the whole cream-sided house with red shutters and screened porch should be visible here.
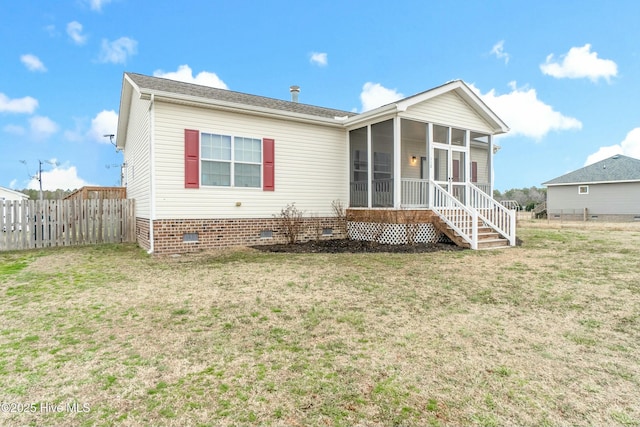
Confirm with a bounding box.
[116,73,515,253]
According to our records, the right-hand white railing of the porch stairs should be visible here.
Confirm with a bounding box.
[468,184,516,246]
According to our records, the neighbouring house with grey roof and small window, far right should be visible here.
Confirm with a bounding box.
[542,154,640,221]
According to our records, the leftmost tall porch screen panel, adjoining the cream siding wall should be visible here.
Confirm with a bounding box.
[349,127,369,208]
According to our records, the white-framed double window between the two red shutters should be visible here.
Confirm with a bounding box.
[200,133,262,188]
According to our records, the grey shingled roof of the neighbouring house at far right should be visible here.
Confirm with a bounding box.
[542,154,640,185]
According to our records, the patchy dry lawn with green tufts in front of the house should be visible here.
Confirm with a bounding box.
[0,223,640,426]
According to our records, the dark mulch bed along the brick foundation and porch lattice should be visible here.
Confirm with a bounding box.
[253,239,464,254]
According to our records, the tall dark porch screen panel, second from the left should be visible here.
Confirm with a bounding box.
[371,120,393,208]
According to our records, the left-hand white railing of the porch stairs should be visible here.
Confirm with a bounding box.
[431,181,478,249]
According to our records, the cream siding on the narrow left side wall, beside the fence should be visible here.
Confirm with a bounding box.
[124,96,151,219]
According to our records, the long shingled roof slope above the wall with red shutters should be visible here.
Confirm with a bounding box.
[125,73,357,119]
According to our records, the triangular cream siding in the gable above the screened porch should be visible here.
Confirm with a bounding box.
[402,92,492,134]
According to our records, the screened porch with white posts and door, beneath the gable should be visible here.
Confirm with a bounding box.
[349,117,494,209]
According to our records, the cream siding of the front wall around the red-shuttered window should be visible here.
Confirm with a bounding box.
[154,101,349,219]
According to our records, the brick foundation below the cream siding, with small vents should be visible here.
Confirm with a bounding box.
[136,217,346,254]
